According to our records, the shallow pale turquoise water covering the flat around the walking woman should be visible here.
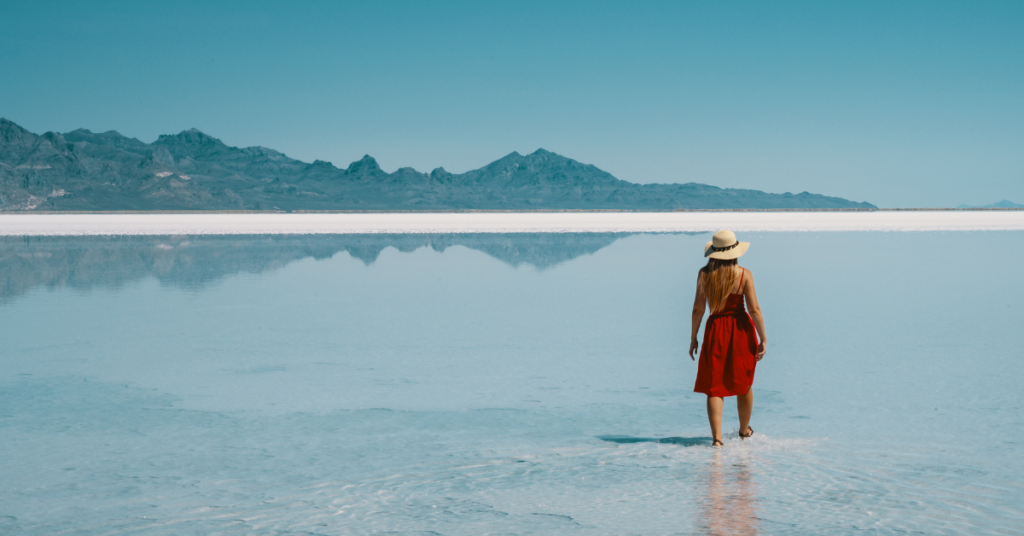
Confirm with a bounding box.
[0,232,1024,535]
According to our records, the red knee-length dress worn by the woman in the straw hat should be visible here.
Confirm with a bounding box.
[693,271,758,397]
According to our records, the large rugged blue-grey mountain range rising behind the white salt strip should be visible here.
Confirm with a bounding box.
[0,119,876,211]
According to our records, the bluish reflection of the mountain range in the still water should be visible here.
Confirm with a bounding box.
[0,233,629,303]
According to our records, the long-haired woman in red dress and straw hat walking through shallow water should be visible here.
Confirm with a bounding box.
[690,231,766,447]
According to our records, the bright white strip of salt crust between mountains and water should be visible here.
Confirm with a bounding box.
[0,211,1024,236]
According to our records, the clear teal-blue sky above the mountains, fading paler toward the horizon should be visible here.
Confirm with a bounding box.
[0,0,1024,207]
